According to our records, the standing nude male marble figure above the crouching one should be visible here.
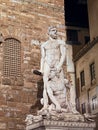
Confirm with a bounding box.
[40,27,66,111]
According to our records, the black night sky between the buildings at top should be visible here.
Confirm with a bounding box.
[65,0,88,27]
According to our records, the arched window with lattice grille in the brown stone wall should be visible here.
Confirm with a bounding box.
[3,38,21,78]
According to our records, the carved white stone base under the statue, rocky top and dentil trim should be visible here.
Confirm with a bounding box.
[26,113,96,130]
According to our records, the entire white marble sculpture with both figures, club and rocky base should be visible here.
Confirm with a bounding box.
[25,26,95,130]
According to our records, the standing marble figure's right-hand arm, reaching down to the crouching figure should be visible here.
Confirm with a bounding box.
[57,42,66,70]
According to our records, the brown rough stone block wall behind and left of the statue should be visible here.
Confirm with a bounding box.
[0,0,65,130]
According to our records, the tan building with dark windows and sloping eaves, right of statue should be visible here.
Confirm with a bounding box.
[75,38,98,114]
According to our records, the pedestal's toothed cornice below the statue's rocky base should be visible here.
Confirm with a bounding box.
[26,119,96,130]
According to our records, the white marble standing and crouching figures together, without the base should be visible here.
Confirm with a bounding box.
[40,26,67,112]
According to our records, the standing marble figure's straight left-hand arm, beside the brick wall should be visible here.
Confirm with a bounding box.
[40,45,45,73]
